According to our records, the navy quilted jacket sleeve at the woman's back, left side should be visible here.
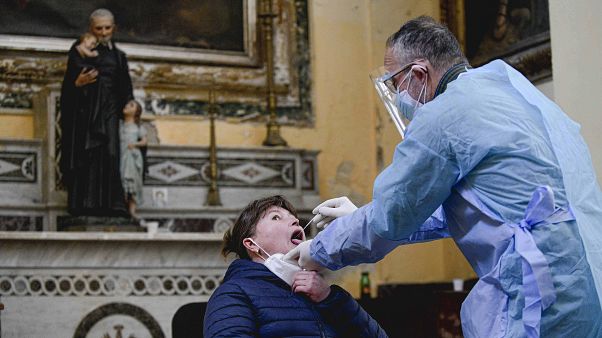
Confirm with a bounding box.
[203,284,258,337]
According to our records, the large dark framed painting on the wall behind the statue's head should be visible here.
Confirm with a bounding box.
[0,0,259,66]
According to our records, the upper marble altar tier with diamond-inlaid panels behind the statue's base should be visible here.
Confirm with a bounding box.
[0,139,320,233]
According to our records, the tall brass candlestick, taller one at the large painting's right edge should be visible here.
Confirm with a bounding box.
[259,0,287,146]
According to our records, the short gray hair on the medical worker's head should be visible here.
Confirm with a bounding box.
[387,16,468,73]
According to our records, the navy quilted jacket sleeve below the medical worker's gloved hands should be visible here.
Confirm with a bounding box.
[316,285,388,338]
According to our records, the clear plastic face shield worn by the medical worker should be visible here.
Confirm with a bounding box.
[370,62,415,137]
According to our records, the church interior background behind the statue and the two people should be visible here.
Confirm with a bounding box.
[0,0,602,338]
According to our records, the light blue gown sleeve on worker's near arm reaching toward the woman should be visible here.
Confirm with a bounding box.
[310,100,474,270]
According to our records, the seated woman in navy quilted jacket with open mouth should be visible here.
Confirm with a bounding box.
[203,196,387,337]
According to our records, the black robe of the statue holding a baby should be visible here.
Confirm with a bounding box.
[59,44,133,216]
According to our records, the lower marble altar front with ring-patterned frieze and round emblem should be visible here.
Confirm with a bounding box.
[0,232,229,338]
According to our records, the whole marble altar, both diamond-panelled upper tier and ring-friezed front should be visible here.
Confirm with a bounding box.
[0,140,319,338]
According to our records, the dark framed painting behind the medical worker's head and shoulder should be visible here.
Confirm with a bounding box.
[440,0,552,82]
